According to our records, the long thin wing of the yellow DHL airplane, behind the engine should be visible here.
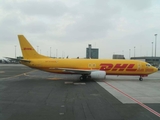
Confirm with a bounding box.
[50,68,95,75]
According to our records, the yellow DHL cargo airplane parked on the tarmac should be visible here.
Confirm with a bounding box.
[18,35,158,81]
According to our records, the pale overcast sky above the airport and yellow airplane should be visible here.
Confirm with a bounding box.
[0,0,160,58]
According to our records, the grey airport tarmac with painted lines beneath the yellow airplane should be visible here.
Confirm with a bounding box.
[0,64,160,120]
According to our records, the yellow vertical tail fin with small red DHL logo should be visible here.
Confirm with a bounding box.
[18,35,48,59]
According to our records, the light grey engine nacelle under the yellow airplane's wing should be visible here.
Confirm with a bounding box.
[90,71,106,79]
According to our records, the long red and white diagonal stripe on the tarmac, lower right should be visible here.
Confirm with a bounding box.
[103,81,160,117]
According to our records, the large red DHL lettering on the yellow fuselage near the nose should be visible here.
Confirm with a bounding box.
[100,63,137,71]
